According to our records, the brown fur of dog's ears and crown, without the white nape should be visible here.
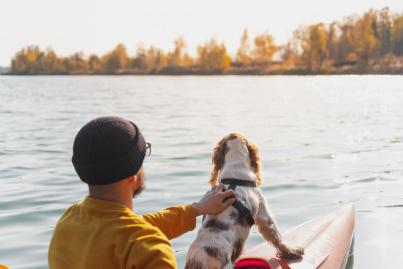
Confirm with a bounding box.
[209,133,262,186]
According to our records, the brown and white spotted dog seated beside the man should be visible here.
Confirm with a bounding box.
[185,133,304,269]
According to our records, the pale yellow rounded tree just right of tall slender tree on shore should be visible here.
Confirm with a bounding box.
[253,31,278,66]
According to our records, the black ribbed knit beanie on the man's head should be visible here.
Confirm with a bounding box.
[72,117,146,185]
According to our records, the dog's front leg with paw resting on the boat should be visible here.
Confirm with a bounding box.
[256,190,304,260]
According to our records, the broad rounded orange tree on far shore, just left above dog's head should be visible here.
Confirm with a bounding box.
[197,37,231,69]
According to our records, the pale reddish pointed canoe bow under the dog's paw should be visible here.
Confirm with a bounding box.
[235,203,355,269]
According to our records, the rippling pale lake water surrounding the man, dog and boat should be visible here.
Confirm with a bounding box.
[0,76,403,269]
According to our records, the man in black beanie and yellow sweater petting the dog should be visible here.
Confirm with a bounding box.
[48,117,235,269]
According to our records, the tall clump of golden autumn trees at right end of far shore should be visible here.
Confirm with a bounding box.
[288,7,403,69]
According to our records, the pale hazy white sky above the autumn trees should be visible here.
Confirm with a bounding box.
[0,0,403,67]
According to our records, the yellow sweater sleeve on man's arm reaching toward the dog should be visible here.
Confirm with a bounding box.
[142,205,196,240]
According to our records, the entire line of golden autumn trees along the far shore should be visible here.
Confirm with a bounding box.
[11,7,403,74]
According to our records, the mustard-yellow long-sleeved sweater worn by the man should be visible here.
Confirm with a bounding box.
[48,196,196,269]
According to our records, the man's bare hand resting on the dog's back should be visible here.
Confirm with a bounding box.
[192,183,235,216]
